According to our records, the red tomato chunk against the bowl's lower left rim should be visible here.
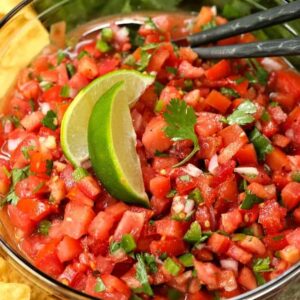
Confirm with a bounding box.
[7,204,36,235]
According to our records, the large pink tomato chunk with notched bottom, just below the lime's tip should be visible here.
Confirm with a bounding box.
[114,211,146,241]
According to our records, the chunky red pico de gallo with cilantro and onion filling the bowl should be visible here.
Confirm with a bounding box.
[0,7,300,300]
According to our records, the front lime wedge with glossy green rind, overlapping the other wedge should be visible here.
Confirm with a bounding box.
[88,81,149,206]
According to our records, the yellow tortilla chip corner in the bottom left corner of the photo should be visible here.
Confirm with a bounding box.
[0,282,30,300]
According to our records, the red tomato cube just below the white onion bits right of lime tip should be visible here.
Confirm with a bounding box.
[155,219,187,238]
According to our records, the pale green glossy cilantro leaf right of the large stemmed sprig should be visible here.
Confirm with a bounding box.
[226,100,257,125]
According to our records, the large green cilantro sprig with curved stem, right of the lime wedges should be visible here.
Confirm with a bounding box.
[164,99,200,167]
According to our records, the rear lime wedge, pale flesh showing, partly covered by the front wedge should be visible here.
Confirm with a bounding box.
[61,70,154,167]
